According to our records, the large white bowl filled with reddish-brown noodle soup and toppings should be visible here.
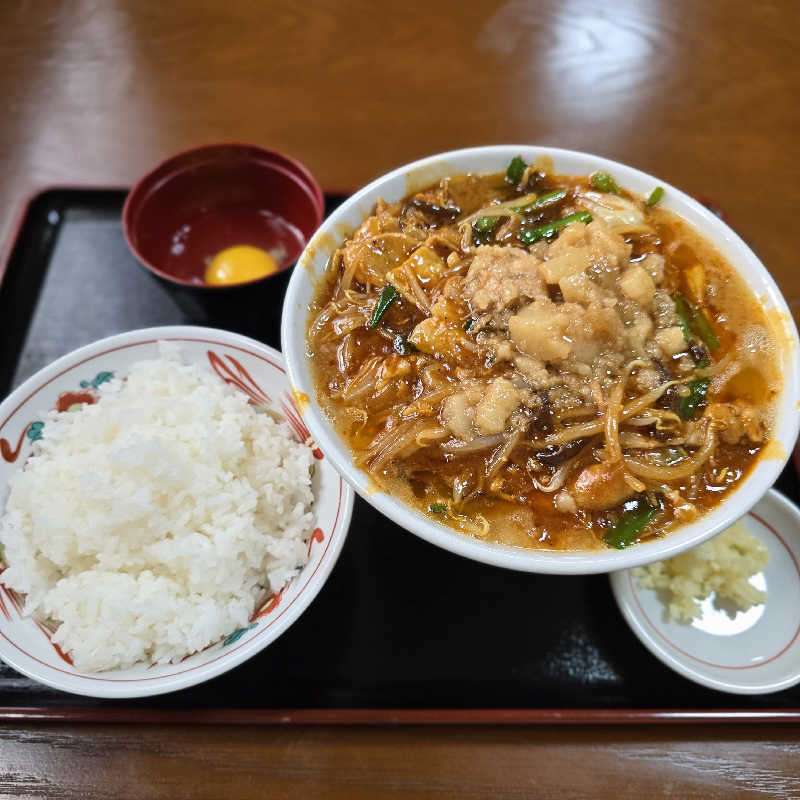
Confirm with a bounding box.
[282,145,800,574]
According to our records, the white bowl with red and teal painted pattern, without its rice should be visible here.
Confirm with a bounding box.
[0,326,353,698]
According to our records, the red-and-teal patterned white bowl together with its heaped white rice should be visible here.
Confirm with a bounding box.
[0,326,353,698]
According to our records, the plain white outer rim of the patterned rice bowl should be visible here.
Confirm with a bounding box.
[0,325,354,699]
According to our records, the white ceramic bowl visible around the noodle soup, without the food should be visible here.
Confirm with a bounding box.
[281,145,800,574]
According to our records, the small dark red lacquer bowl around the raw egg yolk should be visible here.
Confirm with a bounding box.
[122,144,324,332]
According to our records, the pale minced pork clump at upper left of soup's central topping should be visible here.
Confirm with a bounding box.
[464,245,547,313]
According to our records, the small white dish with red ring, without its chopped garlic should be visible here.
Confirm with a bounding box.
[609,489,800,694]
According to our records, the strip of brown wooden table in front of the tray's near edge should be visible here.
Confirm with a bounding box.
[0,725,800,800]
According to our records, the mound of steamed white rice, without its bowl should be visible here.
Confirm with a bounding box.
[0,343,313,671]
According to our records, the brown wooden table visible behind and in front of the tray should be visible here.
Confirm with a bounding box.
[0,0,800,798]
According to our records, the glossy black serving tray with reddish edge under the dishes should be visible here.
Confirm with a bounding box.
[0,188,800,722]
